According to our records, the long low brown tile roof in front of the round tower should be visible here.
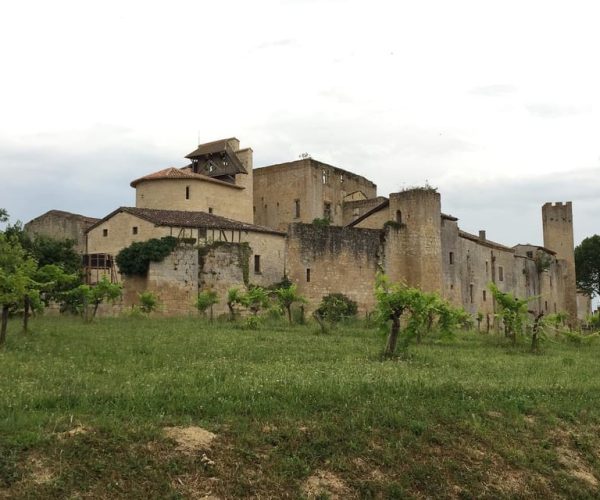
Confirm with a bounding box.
[88,207,285,235]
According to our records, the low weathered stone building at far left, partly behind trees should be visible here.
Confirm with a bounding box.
[23,210,98,254]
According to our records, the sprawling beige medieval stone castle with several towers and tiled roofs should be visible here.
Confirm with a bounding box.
[24,138,590,320]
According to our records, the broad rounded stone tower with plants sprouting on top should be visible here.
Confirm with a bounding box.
[386,188,442,292]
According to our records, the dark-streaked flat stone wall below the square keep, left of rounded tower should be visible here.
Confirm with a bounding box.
[287,224,382,311]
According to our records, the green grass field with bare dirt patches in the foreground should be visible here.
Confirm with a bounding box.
[0,318,600,498]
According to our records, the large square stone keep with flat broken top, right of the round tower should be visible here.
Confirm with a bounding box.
[254,158,377,230]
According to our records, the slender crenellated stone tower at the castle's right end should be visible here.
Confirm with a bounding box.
[542,201,577,323]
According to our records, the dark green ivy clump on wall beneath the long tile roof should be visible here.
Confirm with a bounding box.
[115,236,178,276]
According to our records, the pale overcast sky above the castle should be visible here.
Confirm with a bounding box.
[0,0,600,245]
